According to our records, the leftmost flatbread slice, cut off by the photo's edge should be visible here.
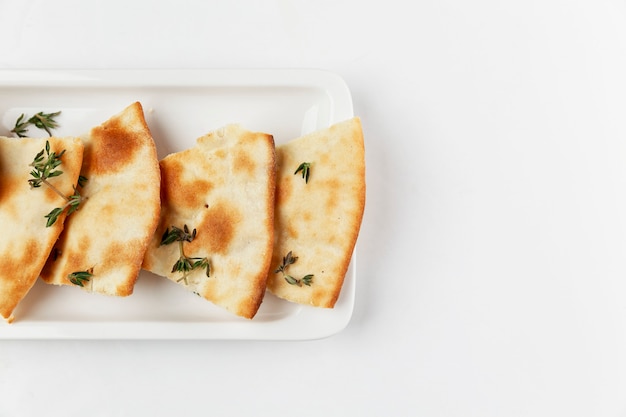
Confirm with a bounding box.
[0,137,83,322]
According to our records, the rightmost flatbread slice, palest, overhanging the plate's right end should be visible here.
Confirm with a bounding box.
[267,117,365,308]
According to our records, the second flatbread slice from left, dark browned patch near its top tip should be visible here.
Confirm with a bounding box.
[41,102,160,296]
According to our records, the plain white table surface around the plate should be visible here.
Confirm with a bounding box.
[0,0,626,417]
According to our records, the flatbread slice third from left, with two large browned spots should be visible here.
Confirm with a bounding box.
[143,125,275,319]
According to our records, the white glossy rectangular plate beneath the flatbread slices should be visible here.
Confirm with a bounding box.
[0,70,356,340]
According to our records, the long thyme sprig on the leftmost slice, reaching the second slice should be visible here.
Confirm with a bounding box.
[28,141,87,227]
